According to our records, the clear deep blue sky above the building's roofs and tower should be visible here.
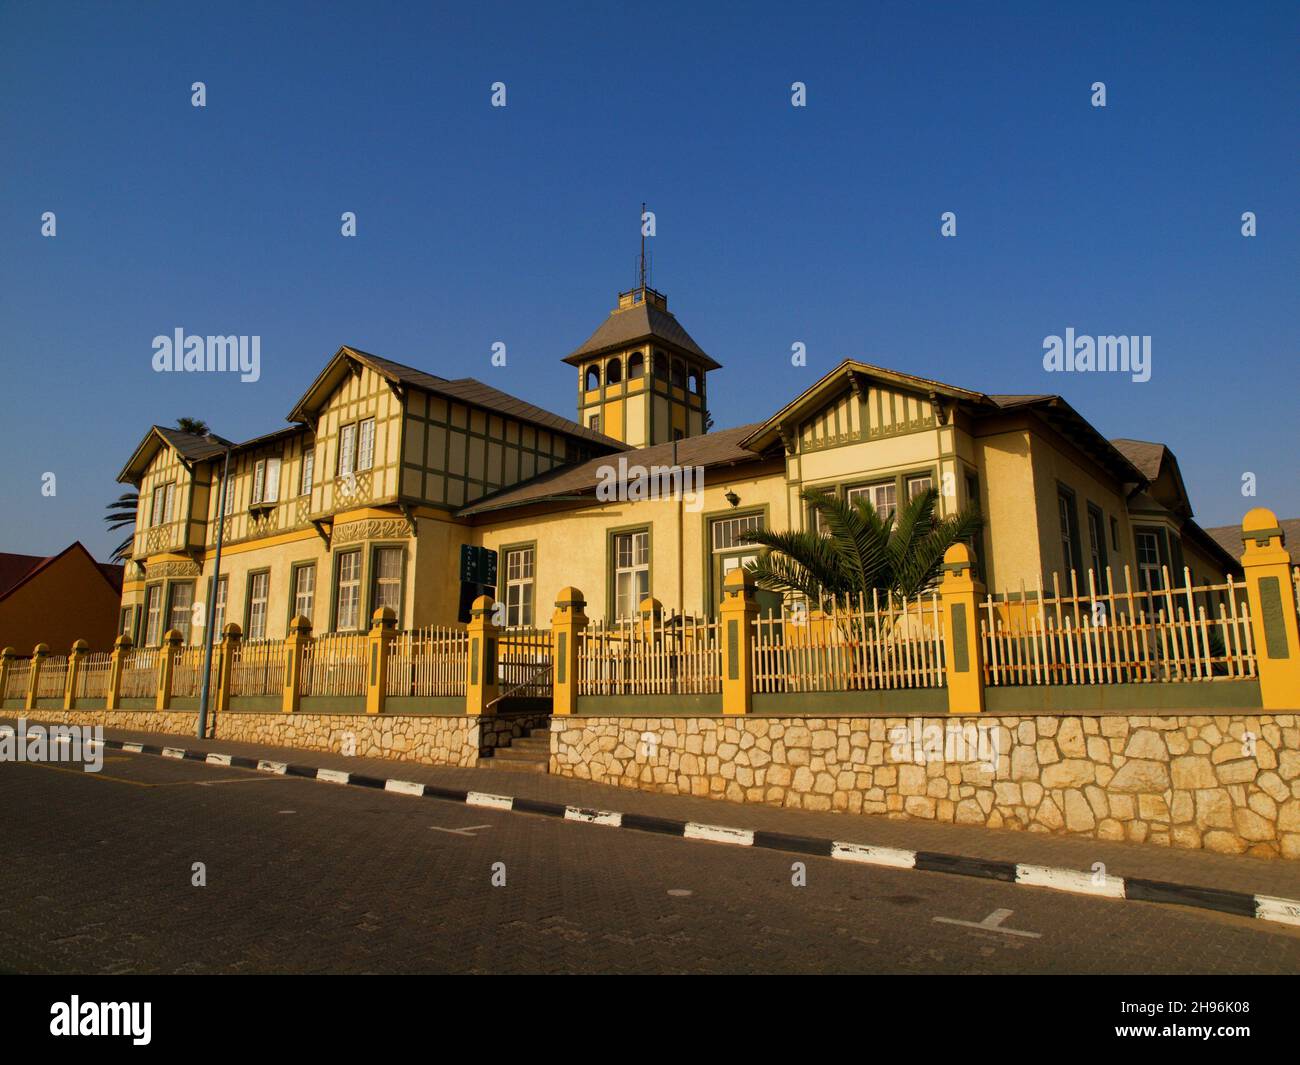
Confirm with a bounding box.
[0,3,1300,558]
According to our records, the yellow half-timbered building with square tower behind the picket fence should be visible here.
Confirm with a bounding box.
[111,279,1236,645]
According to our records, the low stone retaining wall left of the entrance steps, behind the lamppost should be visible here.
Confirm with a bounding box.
[5,710,549,766]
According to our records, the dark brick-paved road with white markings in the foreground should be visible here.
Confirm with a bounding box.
[0,753,1300,973]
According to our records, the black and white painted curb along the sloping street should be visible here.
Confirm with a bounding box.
[35,740,1300,926]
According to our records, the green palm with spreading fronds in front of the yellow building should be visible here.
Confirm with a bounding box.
[742,488,983,603]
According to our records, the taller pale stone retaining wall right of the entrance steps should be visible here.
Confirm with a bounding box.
[550,714,1300,858]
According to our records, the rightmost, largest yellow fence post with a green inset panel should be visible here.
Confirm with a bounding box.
[1242,507,1300,710]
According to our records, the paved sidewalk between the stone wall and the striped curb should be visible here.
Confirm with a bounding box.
[10,715,1300,899]
